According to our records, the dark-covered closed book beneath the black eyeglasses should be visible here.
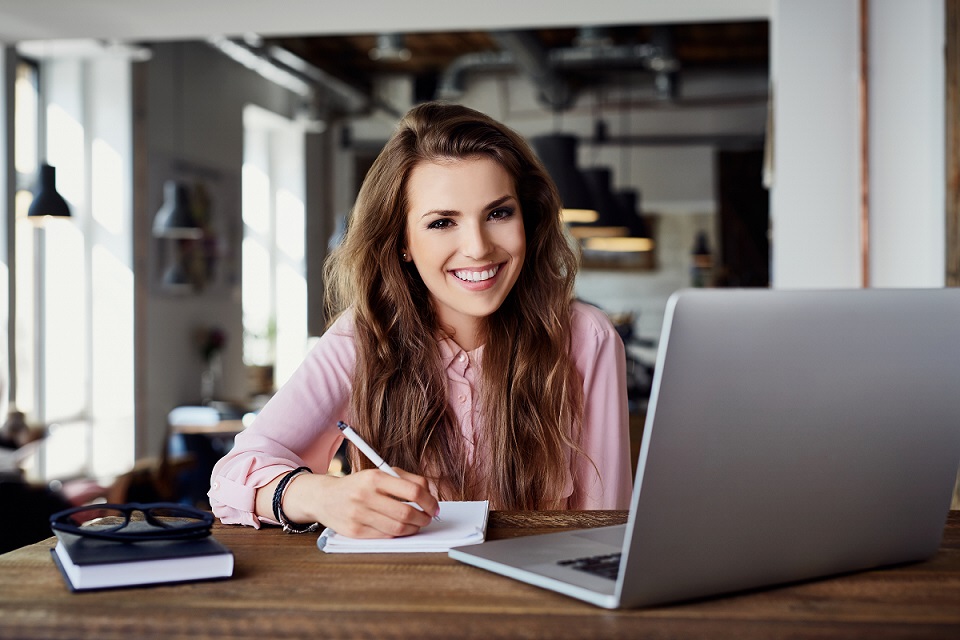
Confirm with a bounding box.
[50,531,233,591]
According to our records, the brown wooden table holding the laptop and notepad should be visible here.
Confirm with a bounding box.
[0,511,960,640]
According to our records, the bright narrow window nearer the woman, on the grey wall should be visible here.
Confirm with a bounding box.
[242,106,307,386]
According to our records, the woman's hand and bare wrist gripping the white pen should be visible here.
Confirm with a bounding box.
[257,469,440,538]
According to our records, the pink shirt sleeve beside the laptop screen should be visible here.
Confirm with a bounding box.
[568,303,633,509]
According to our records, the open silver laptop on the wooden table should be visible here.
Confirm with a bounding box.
[449,289,960,609]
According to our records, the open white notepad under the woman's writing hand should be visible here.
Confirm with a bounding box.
[317,500,490,553]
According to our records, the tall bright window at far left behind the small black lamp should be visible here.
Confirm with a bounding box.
[13,58,134,480]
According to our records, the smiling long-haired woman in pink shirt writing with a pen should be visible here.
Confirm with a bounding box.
[209,103,631,537]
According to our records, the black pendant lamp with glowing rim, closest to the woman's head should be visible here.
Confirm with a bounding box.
[530,133,598,224]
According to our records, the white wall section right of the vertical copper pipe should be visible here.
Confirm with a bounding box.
[869,0,946,287]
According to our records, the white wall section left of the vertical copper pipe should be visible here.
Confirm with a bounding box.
[770,0,861,288]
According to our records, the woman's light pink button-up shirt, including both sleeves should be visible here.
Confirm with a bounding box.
[208,303,632,527]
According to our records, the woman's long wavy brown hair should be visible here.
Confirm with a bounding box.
[325,102,583,509]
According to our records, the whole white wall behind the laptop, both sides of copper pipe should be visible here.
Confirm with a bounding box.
[771,0,946,288]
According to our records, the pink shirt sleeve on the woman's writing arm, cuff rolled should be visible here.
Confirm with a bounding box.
[207,315,356,528]
